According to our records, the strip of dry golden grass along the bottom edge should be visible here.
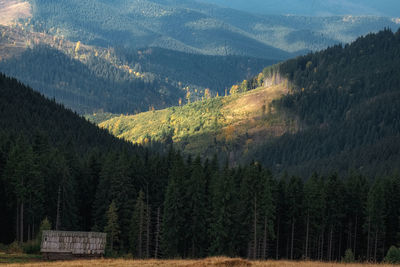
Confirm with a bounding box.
[5,257,394,267]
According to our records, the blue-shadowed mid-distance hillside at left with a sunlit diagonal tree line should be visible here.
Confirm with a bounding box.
[0,26,276,114]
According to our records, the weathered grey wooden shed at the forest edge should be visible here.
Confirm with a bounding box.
[40,231,107,260]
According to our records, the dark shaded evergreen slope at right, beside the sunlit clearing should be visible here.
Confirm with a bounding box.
[248,30,400,179]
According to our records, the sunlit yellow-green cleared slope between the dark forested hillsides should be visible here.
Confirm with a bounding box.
[100,79,297,159]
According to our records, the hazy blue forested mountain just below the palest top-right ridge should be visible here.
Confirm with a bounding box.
[32,0,398,60]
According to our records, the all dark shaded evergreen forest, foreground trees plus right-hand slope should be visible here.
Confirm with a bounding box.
[0,27,400,261]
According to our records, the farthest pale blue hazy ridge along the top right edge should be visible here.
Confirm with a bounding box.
[199,0,400,17]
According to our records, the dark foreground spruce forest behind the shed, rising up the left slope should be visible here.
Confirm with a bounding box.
[0,74,400,261]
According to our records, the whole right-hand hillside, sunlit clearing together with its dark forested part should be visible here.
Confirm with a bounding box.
[100,30,400,179]
